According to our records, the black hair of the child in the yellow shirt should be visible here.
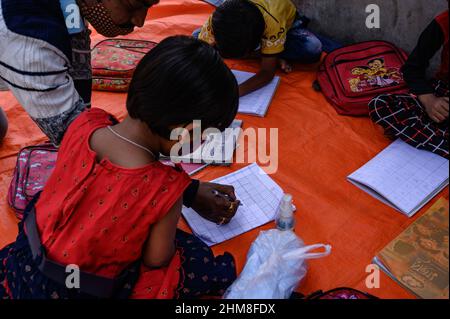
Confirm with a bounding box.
[212,0,266,58]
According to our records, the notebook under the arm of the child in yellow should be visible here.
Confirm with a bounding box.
[232,70,280,117]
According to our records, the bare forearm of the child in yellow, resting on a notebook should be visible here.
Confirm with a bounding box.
[239,56,278,96]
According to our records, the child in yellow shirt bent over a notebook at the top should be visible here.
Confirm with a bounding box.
[194,0,340,96]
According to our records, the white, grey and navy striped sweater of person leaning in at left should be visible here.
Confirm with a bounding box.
[0,0,89,145]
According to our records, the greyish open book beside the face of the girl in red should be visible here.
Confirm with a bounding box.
[163,120,242,165]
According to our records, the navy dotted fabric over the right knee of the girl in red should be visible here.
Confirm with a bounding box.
[177,230,236,298]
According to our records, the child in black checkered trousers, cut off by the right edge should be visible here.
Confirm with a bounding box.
[369,10,449,158]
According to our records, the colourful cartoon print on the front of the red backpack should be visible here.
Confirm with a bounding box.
[348,57,403,92]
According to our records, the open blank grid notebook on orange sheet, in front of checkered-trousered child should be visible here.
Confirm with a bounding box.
[348,140,449,217]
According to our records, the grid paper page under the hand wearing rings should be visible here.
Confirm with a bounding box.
[182,163,283,246]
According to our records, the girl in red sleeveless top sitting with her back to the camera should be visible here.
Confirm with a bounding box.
[0,36,238,299]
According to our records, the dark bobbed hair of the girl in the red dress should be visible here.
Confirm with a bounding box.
[127,36,239,139]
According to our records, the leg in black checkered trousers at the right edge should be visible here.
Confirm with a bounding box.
[369,94,449,158]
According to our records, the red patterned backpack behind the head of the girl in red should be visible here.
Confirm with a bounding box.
[92,39,157,92]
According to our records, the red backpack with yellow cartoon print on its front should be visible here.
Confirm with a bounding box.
[317,41,408,116]
